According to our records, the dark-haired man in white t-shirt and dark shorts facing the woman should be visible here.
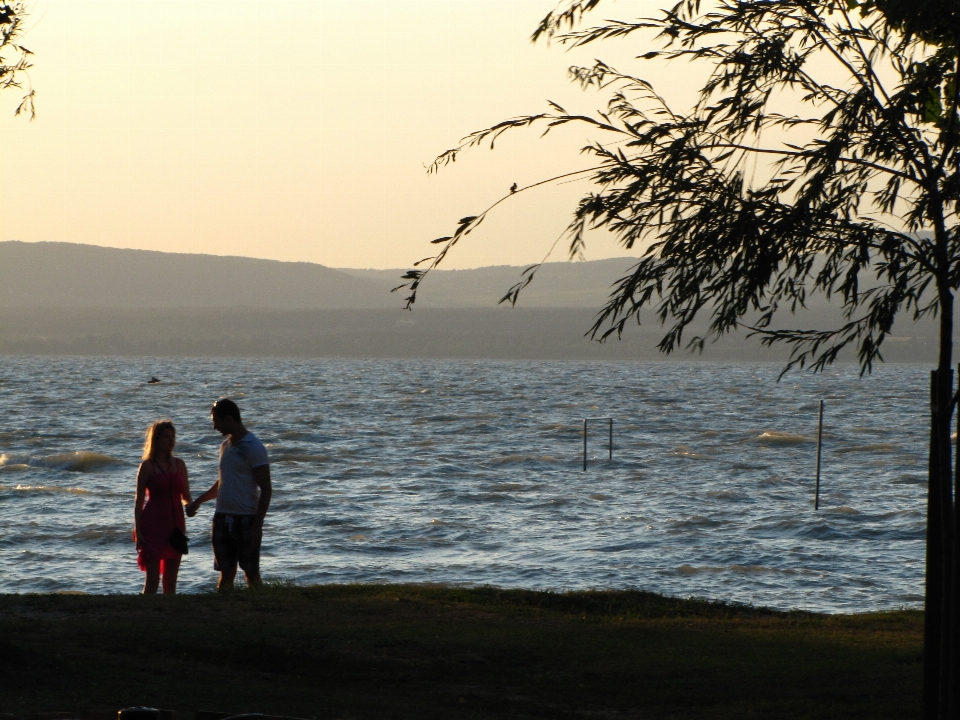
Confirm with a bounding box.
[187,398,273,592]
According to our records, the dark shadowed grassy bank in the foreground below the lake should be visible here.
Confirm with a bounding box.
[0,585,922,720]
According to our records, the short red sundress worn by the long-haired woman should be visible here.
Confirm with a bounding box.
[137,463,187,571]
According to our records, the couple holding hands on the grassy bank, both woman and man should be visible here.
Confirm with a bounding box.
[133,398,273,594]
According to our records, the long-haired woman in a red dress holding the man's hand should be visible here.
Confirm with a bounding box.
[133,420,192,595]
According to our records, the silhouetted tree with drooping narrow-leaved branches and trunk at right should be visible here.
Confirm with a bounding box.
[397,0,960,718]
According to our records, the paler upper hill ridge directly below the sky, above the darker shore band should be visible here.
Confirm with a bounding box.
[0,241,635,310]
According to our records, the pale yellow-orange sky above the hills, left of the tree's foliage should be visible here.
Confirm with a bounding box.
[0,0,696,268]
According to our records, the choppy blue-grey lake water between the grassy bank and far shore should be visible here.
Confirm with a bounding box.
[0,357,928,611]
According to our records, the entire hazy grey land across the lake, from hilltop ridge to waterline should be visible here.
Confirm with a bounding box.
[0,241,938,363]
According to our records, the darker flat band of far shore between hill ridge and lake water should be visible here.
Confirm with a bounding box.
[0,307,937,363]
